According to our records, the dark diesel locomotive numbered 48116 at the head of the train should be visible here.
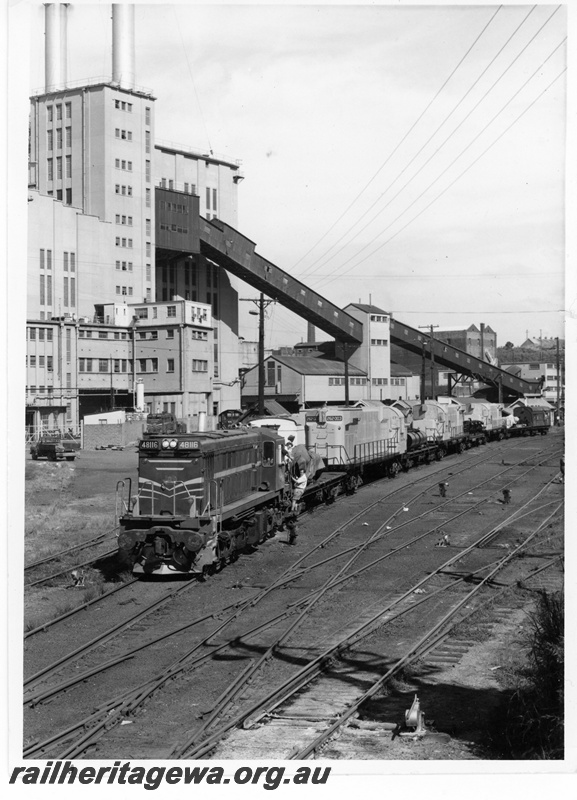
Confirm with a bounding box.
[117,428,290,575]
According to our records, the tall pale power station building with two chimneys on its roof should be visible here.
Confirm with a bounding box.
[26,4,242,430]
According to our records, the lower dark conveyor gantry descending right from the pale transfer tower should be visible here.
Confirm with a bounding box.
[391,318,541,395]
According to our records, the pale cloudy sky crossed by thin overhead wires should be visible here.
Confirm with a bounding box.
[22,3,567,347]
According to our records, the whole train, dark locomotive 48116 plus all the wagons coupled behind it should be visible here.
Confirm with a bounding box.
[117,398,550,575]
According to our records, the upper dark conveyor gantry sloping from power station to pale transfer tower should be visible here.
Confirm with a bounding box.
[199,217,363,344]
